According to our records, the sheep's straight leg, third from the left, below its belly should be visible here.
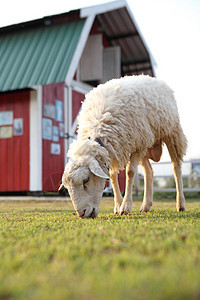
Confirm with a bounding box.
[140,156,153,212]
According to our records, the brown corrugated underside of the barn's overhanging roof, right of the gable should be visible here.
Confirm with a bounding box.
[98,7,153,75]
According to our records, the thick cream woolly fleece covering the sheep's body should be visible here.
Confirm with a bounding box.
[68,75,187,172]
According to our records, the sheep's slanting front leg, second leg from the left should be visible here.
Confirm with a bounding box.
[120,153,141,215]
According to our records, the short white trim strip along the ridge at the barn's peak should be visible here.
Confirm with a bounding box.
[80,0,127,18]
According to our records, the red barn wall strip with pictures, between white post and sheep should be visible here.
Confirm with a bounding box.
[42,83,65,191]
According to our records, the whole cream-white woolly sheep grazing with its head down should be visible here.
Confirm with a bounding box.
[60,75,187,218]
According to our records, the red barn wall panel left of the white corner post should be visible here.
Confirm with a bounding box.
[0,91,30,192]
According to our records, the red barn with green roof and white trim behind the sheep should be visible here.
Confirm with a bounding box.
[0,0,155,192]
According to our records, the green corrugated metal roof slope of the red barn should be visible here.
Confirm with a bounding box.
[0,19,85,92]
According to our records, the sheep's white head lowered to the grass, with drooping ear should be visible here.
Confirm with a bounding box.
[60,139,109,218]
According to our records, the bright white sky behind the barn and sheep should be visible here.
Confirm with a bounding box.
[0,0,200,159]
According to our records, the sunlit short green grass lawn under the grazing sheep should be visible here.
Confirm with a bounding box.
[0,199,200,300]
